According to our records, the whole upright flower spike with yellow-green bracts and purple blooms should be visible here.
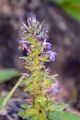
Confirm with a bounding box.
[19,16,67,120]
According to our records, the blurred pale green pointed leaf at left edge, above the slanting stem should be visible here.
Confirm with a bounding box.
[0,69,20,83]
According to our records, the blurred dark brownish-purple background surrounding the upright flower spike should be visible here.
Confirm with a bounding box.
[0,0,80,119]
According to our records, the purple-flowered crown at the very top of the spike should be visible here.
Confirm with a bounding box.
[21,15,50,42]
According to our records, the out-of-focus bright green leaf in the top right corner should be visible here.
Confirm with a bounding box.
[50,0,80,21]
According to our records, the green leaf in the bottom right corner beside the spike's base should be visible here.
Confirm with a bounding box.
[48,111,80,120]
